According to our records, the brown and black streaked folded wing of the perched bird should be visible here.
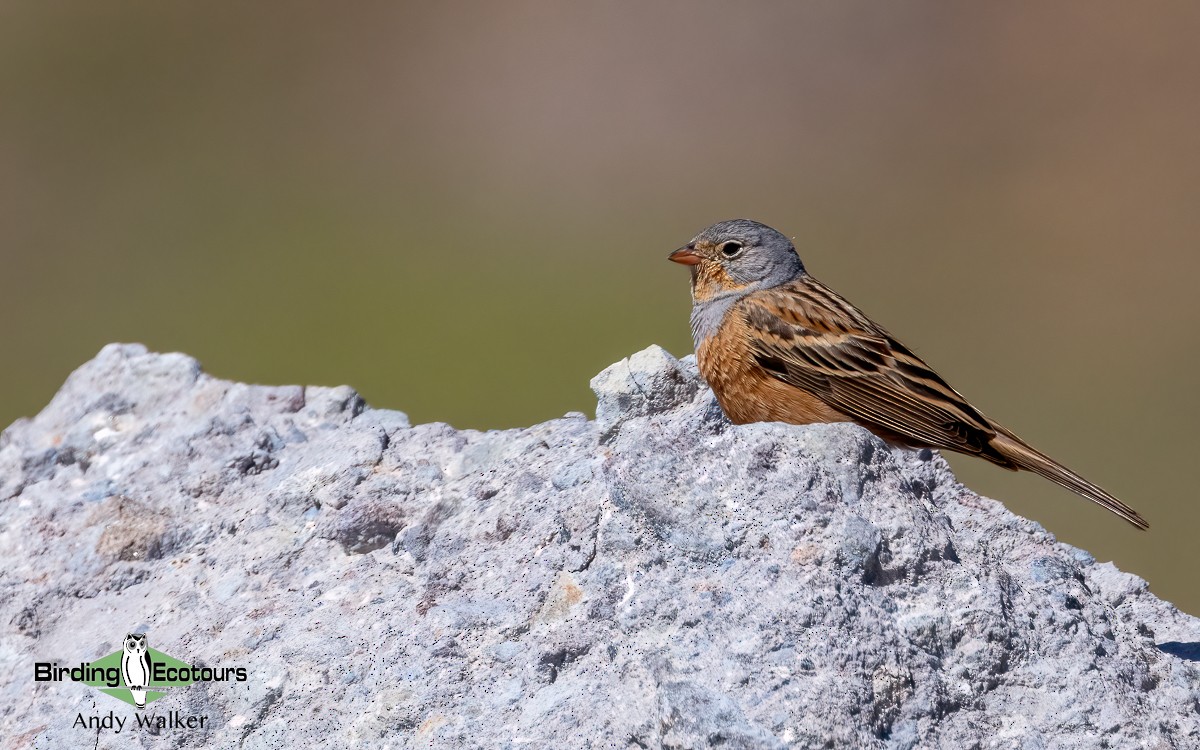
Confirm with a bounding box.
[738,276,1008,456]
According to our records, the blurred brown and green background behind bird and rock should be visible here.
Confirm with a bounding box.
[0,0,1200,613]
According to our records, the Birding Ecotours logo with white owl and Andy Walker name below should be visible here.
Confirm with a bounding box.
[34,632,248,733]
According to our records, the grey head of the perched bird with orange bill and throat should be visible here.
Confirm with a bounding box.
[670,218,804,294]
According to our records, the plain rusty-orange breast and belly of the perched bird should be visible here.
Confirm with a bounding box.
[696,307,854,425]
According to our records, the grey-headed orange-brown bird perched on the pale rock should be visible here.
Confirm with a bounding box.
[668,218,1150,529]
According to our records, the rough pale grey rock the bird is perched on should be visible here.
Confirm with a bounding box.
[0,346,1200,750]
